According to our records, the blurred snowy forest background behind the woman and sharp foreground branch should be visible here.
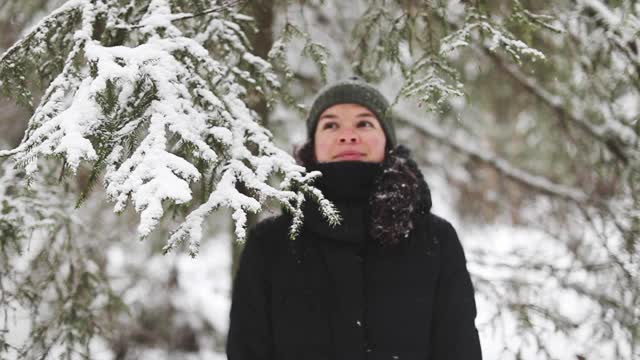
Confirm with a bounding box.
[0,0,640,359]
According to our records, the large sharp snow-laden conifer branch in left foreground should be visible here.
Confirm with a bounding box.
[0,0,338,255]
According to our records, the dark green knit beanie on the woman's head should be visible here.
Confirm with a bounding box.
[307,76,396,149]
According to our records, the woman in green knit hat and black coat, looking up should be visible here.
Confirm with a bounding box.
[227,78,481,360]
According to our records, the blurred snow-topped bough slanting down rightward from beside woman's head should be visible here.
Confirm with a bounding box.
[394,110,588,203]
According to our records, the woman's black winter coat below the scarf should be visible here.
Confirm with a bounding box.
[227,162,481,360]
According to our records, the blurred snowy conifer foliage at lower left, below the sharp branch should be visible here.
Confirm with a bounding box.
[0,159,122,358]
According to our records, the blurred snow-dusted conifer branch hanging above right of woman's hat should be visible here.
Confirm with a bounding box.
[353,3,548,111]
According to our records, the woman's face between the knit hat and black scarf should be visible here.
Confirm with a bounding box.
[314,104,387,163]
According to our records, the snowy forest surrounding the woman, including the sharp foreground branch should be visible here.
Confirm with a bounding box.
[0,0,640,360]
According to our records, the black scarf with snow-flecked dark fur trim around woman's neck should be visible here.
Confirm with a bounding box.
[305,146,431,246]
